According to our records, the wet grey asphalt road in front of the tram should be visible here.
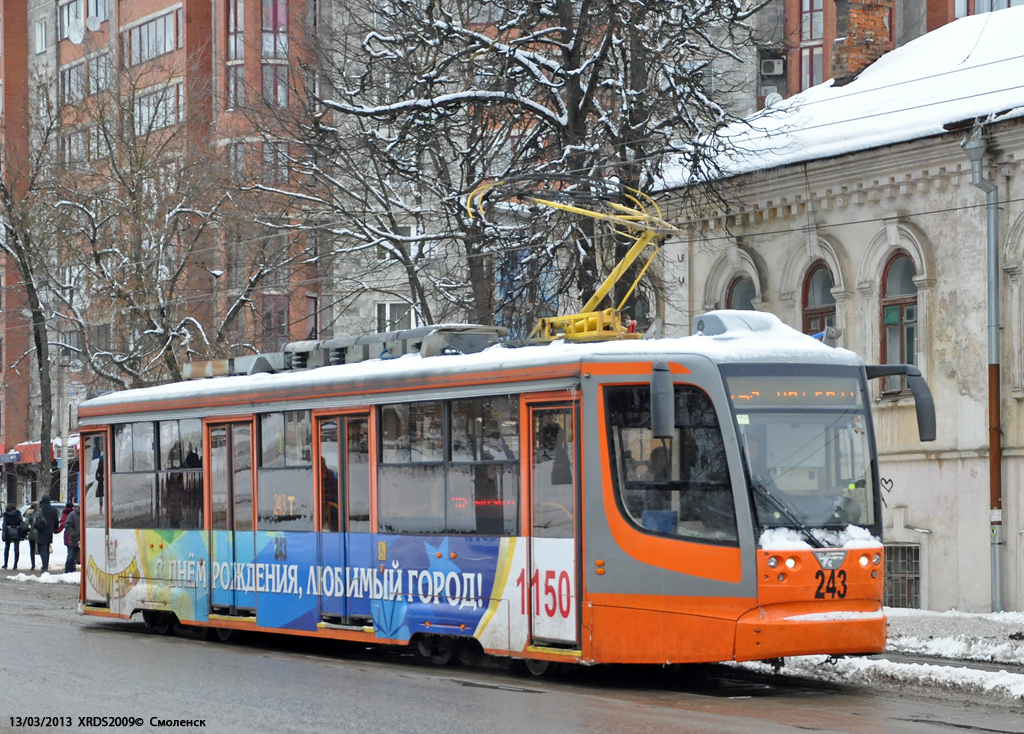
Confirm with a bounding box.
[0,578,1024,734]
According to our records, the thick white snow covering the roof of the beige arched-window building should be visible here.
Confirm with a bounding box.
[665,6,1024,188]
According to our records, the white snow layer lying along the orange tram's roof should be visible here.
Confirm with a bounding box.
[81,311,862,408]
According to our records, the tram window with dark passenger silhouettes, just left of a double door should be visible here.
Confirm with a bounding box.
[157,419,203,530]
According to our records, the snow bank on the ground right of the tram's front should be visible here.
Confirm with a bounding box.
[744,608,1024,701]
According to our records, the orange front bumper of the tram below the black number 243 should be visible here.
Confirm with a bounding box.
[735,600,886,661]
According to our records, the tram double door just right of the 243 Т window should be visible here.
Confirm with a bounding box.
[316,414,371,623]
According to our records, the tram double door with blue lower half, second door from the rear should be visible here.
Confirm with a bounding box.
[207,422,256,614]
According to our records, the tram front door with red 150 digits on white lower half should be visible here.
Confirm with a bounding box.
[523,403,580,644]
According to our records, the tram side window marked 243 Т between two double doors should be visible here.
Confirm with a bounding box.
[257,411,314,530]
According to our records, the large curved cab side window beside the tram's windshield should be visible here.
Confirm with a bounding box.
[605,385,737,544]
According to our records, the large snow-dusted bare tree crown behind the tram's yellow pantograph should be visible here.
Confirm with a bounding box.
[276,0,756,329]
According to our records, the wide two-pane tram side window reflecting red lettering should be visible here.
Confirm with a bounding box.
[377,395,519,535]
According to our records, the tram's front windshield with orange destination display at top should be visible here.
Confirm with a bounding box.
[724,366,876,529]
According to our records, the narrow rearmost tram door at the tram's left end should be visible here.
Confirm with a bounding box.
[79,433,110,604]
